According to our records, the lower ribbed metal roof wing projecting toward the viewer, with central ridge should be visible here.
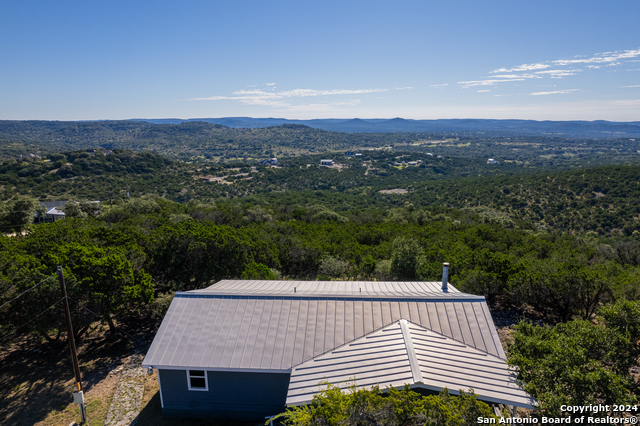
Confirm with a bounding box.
[287,319,534,408]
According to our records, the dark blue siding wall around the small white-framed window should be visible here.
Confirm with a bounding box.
[158,370,290,421]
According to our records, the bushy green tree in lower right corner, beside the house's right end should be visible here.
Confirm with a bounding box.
[507,302,640,417]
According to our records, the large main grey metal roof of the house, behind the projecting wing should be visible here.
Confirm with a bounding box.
[143,280,505,371]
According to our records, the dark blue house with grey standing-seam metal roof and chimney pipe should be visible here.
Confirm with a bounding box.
[142,266,535,421]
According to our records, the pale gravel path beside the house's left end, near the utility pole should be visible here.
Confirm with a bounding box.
[105,354,145,426]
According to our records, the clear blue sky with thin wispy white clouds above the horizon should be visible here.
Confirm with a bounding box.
[0,0,640,121]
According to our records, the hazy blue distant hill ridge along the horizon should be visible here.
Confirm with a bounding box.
[135,117,640,139]
